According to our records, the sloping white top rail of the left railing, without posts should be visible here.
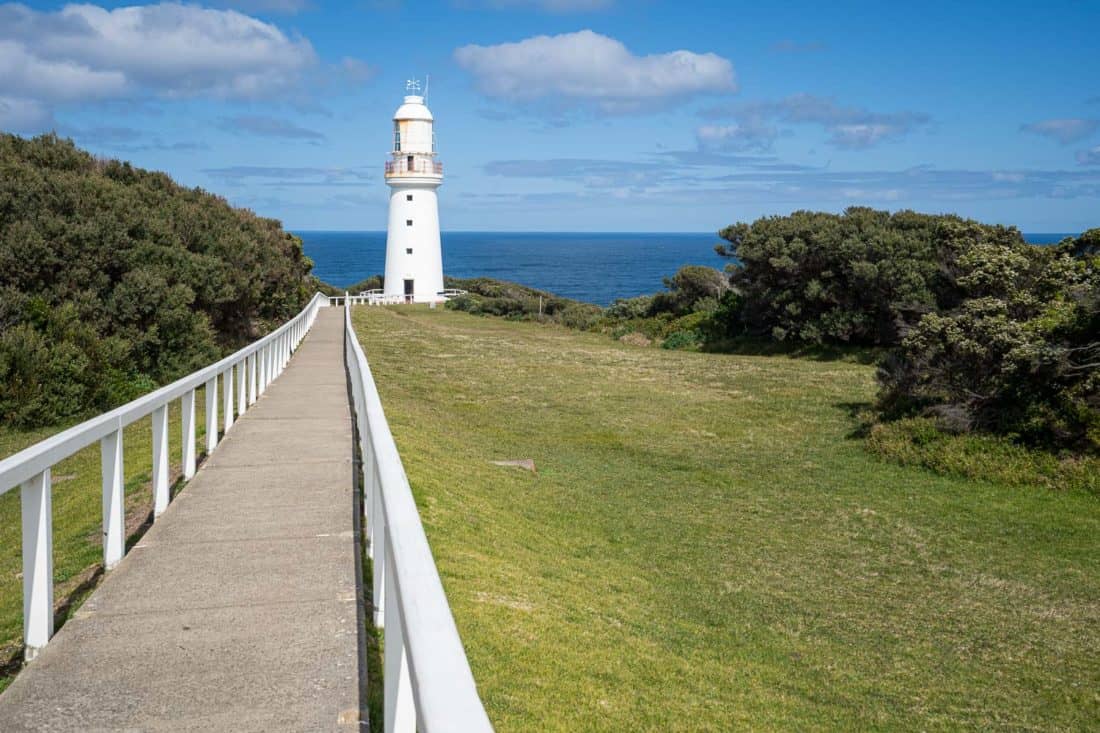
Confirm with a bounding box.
[0,293,328,494]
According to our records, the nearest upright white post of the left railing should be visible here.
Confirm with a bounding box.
[20,469,54,661]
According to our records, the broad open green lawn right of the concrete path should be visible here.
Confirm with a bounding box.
[355,308,1100,732]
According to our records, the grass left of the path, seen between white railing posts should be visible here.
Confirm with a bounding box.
[0,385,212,689]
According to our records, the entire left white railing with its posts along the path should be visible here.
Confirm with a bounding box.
[0,293,329,660]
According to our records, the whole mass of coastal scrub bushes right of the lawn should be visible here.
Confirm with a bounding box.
[719,208,1100,453]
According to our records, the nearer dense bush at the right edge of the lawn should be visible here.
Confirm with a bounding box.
[879,230,1100,451]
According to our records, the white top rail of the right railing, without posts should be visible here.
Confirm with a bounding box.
[344,309,493,733]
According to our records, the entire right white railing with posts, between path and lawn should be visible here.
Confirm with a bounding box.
[344,307,493,733]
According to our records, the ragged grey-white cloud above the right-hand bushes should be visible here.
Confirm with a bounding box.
[696,94,931,150]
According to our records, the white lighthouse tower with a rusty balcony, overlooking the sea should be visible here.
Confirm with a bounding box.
[383,81,443,303]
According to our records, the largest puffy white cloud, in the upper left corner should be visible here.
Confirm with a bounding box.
[0,3,317,132]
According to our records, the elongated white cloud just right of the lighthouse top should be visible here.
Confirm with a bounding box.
[454,31,737,113]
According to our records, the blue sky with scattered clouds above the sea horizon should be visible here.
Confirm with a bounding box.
[0,0,1100,231]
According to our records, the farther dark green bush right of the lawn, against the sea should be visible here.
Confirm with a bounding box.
[717,208,1034,346]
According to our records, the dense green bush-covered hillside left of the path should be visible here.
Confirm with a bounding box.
[0,134,316,427]
